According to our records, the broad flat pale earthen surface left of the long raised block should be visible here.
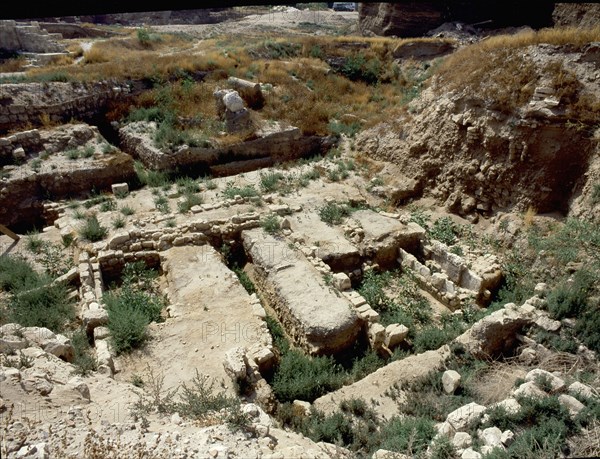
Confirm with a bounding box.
[119,245,271,394]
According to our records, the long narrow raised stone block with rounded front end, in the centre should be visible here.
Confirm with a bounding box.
[242,228,361,354]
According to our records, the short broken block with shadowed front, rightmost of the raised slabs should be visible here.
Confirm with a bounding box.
[352,210,425,267]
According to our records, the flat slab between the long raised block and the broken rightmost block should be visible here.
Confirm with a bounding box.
[288,212,361,272]
